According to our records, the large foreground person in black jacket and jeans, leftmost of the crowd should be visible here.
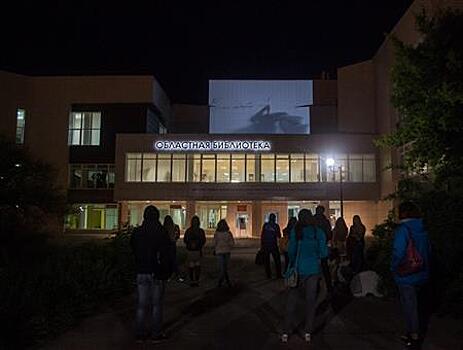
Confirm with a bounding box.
[131,205,172,342]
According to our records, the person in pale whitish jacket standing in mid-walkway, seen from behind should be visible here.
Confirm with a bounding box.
[214,219,235,288]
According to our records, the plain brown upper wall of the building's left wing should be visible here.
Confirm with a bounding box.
[0,72,167,188]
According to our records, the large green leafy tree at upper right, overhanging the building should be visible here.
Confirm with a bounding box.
[379,9,463,184]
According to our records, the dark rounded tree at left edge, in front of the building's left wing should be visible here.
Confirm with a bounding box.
[0,138,66,234]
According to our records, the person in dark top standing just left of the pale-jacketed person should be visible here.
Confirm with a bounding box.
[183,215,206,287]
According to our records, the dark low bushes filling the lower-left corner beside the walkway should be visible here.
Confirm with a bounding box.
[0,234,134,349]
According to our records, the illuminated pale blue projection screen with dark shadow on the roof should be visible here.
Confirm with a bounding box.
[209,80,313,134]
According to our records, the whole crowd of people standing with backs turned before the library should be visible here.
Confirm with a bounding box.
[131,203,430,348]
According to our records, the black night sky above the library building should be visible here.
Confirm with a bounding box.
[0,0,412,104]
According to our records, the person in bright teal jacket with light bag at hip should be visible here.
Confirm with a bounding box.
[280,209,328,343]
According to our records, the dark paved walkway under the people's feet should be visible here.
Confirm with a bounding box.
[45,244,463,350]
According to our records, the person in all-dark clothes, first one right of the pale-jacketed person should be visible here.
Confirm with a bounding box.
[261,213,283,278]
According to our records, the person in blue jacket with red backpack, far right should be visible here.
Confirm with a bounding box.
[391,202,431,349]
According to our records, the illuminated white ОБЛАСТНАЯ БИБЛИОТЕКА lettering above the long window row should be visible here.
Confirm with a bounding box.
[154,140,272,152]
